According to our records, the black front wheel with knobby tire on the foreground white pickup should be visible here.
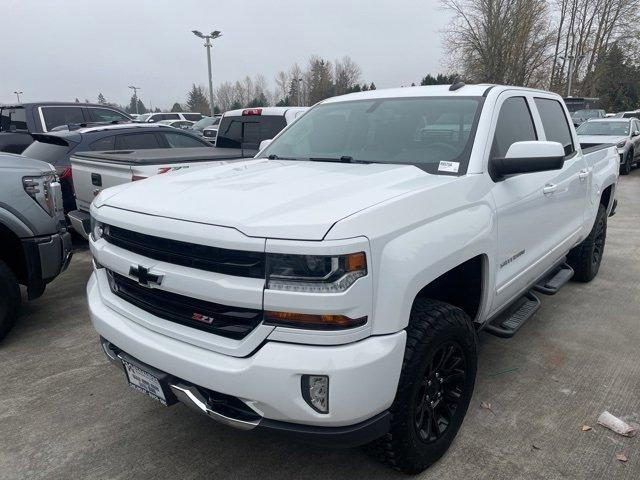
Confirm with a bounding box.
[371,298,477,474]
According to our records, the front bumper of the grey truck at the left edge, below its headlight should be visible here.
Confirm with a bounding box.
[22,230,73,300]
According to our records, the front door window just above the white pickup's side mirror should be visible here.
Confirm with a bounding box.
[491,97,538,157]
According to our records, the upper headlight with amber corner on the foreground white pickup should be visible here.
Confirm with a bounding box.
[267,252,367,293]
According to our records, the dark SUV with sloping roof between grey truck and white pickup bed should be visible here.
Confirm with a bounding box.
[22,123,211,213]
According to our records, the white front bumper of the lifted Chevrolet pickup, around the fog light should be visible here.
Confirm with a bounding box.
[87,271,406,430]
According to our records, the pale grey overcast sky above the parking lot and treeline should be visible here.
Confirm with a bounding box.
[0,0,448,108]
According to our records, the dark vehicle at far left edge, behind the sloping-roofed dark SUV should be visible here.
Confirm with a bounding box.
[0,102,131,153]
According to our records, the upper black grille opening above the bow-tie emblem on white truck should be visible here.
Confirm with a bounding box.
[104,225,265,278]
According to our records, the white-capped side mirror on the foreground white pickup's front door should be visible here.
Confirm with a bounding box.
[489,141,564,181]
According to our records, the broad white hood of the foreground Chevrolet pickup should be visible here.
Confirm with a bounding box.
[101,159,455,240]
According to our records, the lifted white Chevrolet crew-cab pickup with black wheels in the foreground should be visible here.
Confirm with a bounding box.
[87,83,619,473]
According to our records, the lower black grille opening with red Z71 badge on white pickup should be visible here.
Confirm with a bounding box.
[107,270,262,340]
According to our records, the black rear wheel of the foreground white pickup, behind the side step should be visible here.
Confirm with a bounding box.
[567,205,607,283]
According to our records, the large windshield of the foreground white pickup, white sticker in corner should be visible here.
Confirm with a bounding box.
[263,97,483,174]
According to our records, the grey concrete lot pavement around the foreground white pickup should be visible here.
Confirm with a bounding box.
[0,170,640,480]
